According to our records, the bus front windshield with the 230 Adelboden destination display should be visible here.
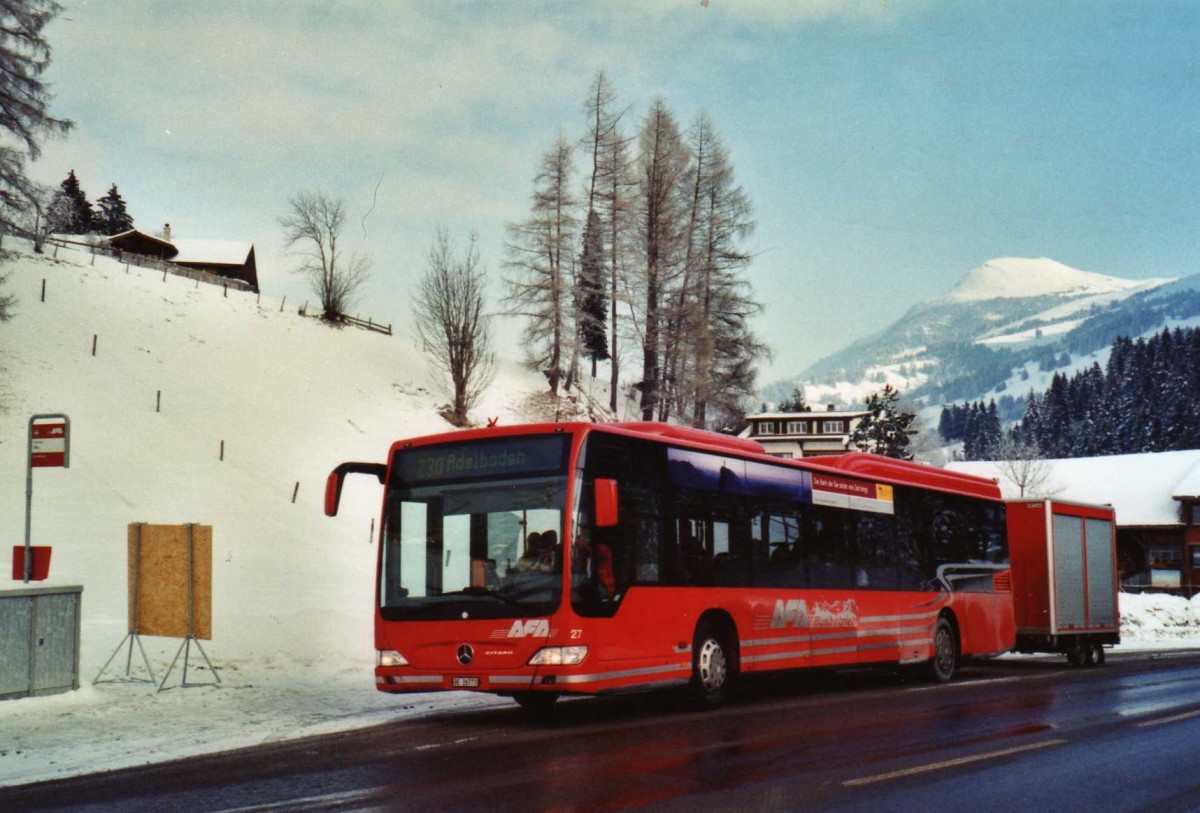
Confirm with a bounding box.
[379,434,569,620]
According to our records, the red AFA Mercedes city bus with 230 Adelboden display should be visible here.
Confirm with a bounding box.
[325,423,1015,709]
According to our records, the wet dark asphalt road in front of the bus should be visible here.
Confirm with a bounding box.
[7,652,1200,813]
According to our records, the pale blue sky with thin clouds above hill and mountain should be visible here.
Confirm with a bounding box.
[36,0,1200,381]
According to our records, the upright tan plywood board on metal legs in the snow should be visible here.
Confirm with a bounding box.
[128,524,212,640]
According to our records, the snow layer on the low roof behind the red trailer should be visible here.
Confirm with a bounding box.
[946,450,1200,526]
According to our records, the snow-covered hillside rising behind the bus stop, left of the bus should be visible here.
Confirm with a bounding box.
[0,241,568,662]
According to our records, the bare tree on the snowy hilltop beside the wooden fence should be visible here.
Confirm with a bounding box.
[280,192,371,321]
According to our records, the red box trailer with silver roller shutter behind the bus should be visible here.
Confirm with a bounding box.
[1006,500,1121,666]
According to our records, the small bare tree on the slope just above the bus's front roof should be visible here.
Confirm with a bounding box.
[413,229,496,426]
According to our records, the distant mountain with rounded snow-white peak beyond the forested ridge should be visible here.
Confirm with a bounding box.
[764,258,1185,418]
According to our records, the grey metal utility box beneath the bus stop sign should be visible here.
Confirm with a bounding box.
[0,586,83,700]
